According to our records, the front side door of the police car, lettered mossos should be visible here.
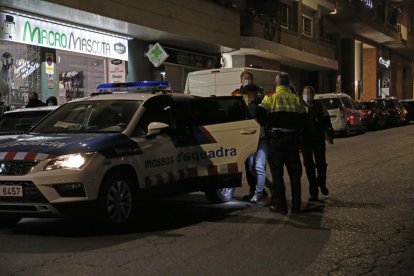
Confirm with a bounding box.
[131,95,182,189]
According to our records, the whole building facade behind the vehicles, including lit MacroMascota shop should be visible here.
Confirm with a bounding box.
[0,0,414,107]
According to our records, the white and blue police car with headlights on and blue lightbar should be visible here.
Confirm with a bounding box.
[0,82,259,225]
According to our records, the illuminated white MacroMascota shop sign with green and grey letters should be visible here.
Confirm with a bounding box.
[0,12,128,60]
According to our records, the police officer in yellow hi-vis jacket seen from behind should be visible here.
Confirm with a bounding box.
[256,72,305,214]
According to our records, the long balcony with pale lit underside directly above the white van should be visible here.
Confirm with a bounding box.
[239,14,338,71]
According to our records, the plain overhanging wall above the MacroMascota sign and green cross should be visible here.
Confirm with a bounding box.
[43,0,240,48]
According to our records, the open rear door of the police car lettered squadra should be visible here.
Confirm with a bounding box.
[184,97,260,188]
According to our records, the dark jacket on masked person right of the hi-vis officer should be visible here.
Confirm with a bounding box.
[303,101,333,145]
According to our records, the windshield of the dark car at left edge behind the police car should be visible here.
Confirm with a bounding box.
[0,110,51,135]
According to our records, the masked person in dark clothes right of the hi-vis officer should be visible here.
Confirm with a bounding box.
[302,86,333,201]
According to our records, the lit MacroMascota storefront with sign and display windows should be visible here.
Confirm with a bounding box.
[0,10,128,108]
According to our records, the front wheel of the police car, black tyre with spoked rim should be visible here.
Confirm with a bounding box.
[99,174,136,225]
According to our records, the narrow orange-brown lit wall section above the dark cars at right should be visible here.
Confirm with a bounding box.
[362,48,377,101]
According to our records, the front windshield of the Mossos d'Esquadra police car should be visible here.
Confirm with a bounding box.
[32,100,142,134]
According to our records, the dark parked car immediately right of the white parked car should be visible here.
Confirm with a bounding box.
[359,100,389,130]
